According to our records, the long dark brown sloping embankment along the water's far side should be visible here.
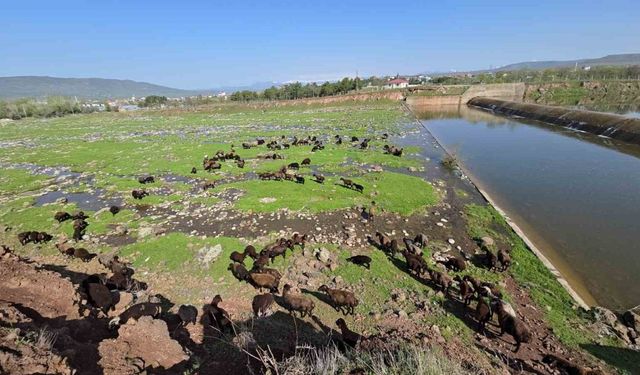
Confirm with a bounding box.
[467,97,640,144]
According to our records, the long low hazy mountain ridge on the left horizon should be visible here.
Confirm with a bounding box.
[0,76,278,99]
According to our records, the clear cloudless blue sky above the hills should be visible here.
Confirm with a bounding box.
[0,0,640,88]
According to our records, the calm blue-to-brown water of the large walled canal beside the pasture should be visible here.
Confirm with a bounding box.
[413,107,640,309]
